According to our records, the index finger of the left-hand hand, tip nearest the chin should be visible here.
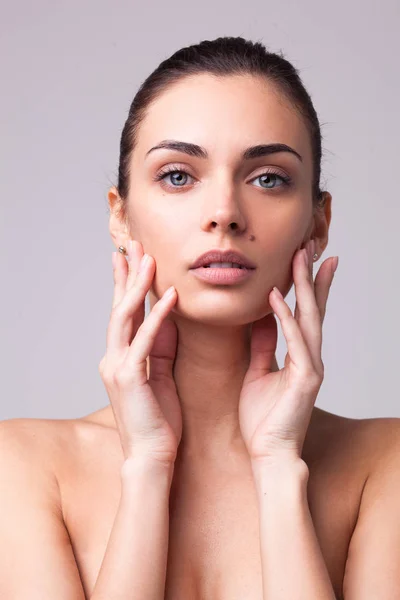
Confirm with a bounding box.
[126,286,178,385]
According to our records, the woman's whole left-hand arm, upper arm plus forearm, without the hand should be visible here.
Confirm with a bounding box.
[0,419,172,600]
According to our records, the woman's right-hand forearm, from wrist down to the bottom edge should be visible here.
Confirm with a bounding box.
[252,459,335,600]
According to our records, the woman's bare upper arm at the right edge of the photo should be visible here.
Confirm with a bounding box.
[343,417,400,600]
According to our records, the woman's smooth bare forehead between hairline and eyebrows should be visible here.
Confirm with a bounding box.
[138,75,311,169]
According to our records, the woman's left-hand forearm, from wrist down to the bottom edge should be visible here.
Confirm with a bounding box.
[90,459,173,600]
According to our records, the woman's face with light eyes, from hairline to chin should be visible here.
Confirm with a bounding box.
[128,75,313,325]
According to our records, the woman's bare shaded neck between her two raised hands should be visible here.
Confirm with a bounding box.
[164,314,278,462]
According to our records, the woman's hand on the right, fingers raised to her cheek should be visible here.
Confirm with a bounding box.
[239,242,335,462]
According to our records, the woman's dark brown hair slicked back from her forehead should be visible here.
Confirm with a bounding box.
[117,37,323,219]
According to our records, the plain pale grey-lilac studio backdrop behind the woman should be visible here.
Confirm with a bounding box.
[0,0,400,419]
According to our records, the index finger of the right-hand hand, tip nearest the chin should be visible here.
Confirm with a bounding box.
[269,288,314,375]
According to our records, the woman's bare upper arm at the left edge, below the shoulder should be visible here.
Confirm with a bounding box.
[0,419,85,600]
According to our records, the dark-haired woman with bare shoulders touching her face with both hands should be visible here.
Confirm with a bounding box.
[0,37,400,600]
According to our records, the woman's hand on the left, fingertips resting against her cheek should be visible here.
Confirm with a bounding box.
[99,241,182,464]
